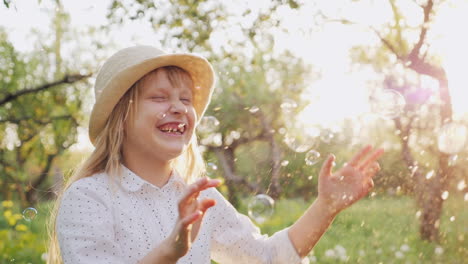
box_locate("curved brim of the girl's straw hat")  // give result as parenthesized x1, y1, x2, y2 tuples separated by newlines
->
(89, 53, 215, 145)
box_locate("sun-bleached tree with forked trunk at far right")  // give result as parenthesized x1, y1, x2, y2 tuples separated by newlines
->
(324, 0, 460, 241)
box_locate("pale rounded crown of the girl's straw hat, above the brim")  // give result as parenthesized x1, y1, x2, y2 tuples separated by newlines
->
(94, 46, 166, 99)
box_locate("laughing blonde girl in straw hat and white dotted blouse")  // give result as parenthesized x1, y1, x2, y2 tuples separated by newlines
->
(49, 46, 383, 264)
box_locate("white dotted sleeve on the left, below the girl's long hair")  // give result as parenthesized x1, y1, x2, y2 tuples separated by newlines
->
(56, 177, 124, 264)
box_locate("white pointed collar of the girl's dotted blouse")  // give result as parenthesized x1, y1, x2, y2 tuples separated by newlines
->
(120, 164, 186, 192)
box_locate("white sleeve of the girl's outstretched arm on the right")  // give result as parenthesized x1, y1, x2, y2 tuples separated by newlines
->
(204, 189, 309, 264)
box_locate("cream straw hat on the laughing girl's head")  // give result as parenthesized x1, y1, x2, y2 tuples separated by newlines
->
(89, 46, 215, 144)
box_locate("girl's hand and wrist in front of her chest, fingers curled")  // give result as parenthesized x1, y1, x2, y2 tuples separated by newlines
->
(167, 178, 221, 261)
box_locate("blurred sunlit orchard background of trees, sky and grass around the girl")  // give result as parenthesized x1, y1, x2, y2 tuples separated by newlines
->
(0, 0, 468, 263)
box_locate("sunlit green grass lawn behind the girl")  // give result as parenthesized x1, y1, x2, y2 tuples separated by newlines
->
(0, 196, 468, 264)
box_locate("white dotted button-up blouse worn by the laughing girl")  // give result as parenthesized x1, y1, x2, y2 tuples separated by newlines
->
(56, 166, 308, 264)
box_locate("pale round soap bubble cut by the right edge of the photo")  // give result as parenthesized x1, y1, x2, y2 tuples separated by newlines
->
(437, 123, 467, 154)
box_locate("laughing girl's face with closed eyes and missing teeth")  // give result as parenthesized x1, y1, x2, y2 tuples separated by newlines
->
(123, 69, 196, 161)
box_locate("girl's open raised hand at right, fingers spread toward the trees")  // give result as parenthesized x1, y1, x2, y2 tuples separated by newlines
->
(318, 145, 384, 213)
